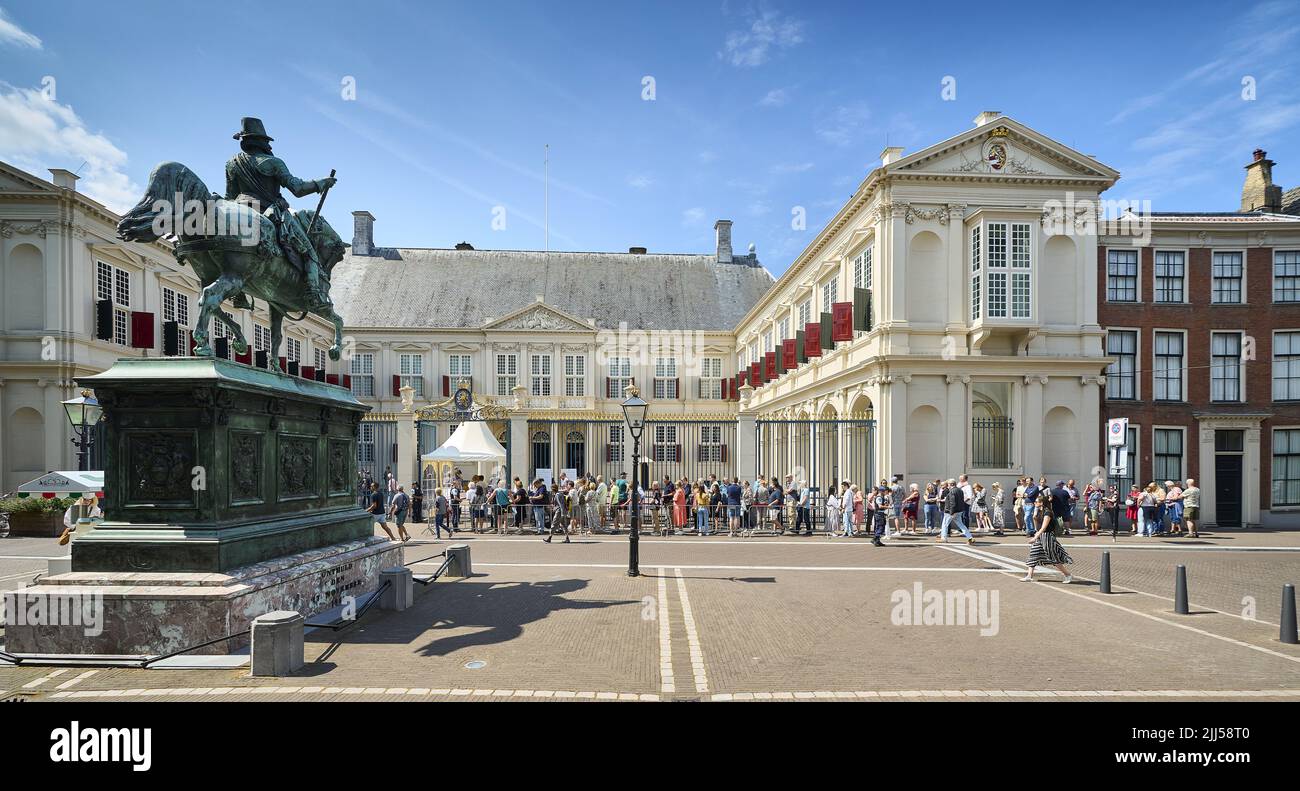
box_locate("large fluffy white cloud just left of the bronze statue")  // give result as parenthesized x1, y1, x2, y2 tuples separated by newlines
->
(0, 82, 144, 213)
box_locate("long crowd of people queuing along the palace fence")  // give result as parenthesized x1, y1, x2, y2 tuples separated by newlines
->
(360, 468, 1200, 582)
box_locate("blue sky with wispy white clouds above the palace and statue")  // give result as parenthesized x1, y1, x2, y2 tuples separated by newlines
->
(0, 0, 1300, 273)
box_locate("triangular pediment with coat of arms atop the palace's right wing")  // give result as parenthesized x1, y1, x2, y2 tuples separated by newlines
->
(885, 116, 1119, 181)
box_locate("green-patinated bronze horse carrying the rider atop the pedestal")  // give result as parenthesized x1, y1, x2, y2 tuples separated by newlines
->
(117, 163, 346, 371)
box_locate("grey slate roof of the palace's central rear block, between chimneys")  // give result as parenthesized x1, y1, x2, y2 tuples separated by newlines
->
(330, 248, 775, 332)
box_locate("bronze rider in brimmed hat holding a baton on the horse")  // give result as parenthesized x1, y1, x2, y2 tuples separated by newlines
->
(225, 118, 335, 308)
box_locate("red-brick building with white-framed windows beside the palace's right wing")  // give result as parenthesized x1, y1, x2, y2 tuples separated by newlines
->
(1097, 151, 1300, 526)
